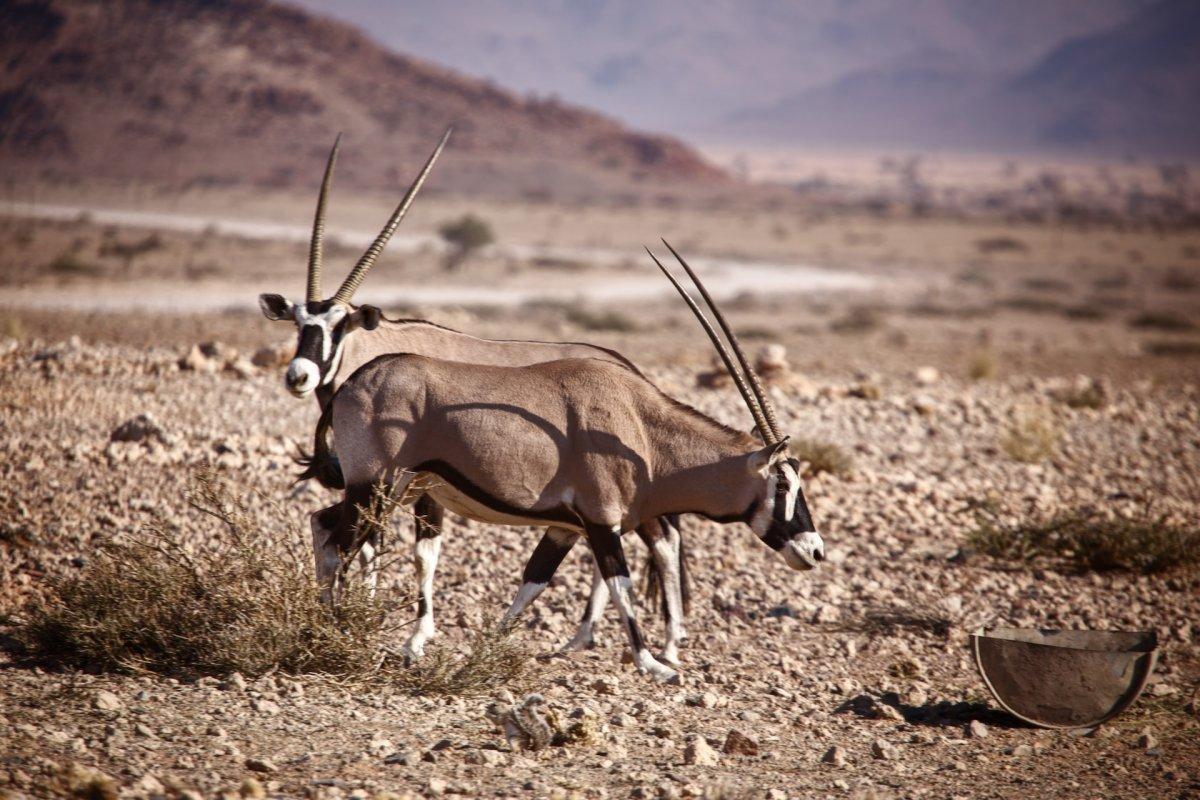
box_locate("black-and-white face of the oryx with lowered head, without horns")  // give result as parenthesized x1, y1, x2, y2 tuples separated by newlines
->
(750, 439, 824, 570)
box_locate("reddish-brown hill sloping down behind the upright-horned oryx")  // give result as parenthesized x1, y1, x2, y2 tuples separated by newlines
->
(0, 0, 726, 197)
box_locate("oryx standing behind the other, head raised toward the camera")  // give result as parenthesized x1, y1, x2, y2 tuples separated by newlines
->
(259, 131, 686, 663)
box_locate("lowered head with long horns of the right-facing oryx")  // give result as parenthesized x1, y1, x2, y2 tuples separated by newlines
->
(646, 240, 824, 570)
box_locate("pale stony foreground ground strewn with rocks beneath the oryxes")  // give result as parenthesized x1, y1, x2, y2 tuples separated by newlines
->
(0, 323, 1200, 798)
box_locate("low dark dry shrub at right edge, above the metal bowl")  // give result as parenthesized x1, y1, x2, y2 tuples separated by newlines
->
(967, 510, 1200, 573)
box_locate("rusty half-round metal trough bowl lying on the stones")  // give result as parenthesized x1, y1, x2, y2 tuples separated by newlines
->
(971, 627, 1158, 728)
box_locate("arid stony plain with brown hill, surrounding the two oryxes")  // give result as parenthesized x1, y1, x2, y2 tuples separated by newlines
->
(0, 0, 1200, 800)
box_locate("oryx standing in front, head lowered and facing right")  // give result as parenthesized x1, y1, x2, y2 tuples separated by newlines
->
(314, 245, 824, 680)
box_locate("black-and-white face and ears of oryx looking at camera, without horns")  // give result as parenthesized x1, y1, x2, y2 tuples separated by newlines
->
(258, 294, 380, 397)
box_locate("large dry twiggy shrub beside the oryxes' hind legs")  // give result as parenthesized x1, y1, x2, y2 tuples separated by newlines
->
(17, 470, 388, 679)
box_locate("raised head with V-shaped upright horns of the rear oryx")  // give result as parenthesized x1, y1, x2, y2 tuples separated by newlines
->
(258, 128, 450, 397)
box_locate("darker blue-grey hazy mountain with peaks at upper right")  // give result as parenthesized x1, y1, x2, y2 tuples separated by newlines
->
(724, 0, 1200, 156)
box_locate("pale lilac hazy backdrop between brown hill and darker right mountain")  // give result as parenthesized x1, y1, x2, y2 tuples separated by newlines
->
(298, 0, 1151, 138)
